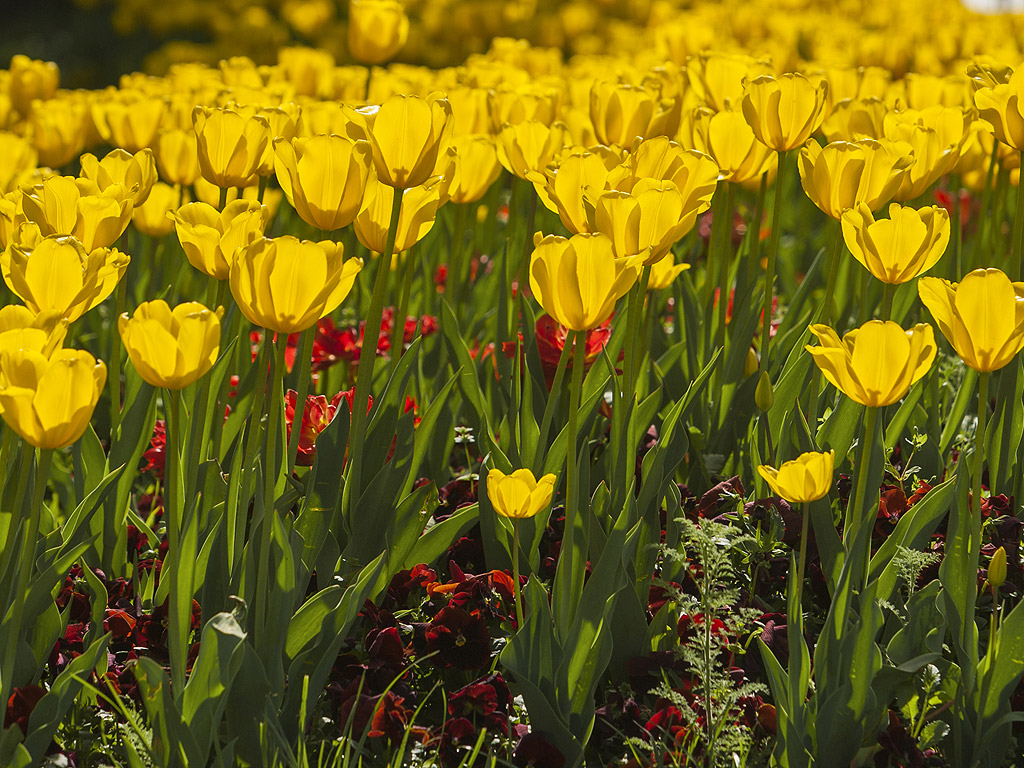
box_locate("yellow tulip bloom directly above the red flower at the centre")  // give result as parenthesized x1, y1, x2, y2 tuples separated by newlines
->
(529, 233, 642, 331)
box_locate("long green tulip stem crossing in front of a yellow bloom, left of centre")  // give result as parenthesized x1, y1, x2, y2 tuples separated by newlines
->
(343, 187, 402, 512)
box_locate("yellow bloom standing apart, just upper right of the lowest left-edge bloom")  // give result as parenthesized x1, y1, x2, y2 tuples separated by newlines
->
(118, 299, 224, 389)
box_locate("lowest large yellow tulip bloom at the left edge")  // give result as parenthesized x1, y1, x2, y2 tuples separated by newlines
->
(0, 349, 106, 449)
